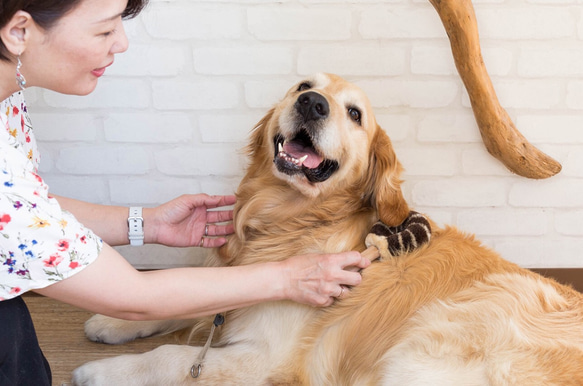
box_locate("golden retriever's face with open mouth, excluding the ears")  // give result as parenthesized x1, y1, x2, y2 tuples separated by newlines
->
(269, 74, 376, 196)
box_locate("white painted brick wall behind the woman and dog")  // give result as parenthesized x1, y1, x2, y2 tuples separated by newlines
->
(27, 0, 583, 267)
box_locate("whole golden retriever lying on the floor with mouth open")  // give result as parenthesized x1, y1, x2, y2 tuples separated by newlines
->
(74, 74, 583, 385)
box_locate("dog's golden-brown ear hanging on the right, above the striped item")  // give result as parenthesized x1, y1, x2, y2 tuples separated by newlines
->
(365, 125, 409, 226)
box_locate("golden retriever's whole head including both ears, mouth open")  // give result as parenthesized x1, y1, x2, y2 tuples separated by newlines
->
(249, 74, 409, 225)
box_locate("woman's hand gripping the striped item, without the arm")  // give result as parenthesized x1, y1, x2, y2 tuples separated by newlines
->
(282, 251, 370, 307)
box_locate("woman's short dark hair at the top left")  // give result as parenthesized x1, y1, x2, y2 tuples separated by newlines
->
(0, 0, 148, 61)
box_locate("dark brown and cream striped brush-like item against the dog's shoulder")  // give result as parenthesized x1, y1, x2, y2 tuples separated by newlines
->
(365, 211, 431, 259)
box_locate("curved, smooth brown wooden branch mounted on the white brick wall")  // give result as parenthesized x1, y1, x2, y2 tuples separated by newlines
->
(429, 0, 561, 179)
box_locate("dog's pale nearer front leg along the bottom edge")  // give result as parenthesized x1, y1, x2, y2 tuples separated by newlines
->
(72, 343, 270, 386)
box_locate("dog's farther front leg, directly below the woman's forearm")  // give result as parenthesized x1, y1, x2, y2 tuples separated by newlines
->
(85, 315, 195, 344)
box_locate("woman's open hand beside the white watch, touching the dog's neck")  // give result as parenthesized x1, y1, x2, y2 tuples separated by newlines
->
(143, 194, 236, 248)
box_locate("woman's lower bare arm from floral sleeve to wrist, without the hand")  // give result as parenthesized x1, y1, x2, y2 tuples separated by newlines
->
(36, 245, 285, 320)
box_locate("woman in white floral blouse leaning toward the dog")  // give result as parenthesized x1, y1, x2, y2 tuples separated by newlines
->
(0, 0, 369, 385)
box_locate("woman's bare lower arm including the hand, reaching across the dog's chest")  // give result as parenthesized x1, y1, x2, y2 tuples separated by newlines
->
(35, 244, 370, 320)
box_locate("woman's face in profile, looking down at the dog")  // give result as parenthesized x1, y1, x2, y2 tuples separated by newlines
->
(21, 0, 128, 95)
